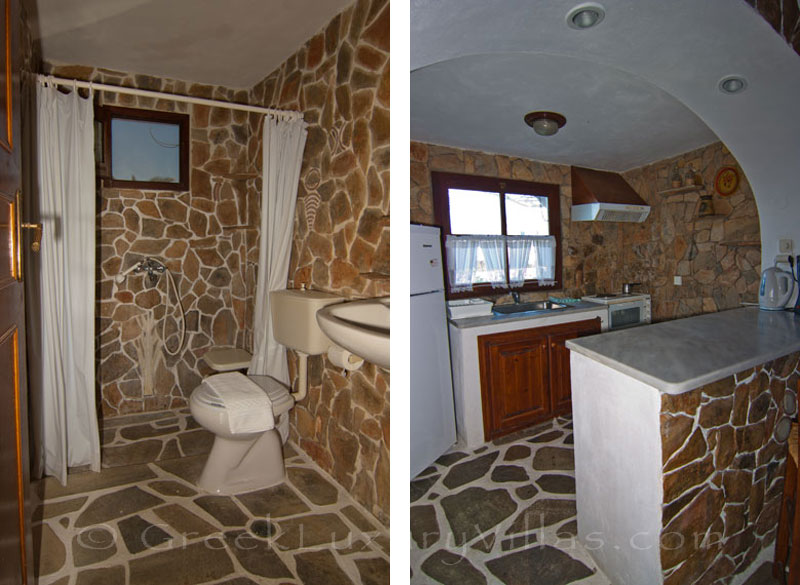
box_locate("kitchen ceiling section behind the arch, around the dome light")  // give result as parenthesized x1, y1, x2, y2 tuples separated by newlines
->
(411, 53, 717, 171)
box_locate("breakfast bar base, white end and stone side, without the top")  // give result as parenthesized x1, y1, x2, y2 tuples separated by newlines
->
(571, 352, 800, 585)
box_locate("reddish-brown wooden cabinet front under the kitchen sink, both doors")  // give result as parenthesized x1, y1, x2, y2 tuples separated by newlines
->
(478, 318, 600, 441)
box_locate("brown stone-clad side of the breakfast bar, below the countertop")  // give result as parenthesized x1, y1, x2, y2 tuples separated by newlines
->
(661, 354, 800, 585)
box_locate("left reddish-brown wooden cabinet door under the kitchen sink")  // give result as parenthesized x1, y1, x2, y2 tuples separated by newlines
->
(478, 329, 550, 441)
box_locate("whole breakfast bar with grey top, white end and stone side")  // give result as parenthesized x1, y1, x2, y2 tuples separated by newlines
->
(567, 308, 800, 585)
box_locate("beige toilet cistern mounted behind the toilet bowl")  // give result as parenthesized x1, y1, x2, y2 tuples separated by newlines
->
(269, 289, 344, 355)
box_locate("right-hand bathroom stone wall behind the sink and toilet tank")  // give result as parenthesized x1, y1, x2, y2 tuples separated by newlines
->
(249, 0, 389, 523)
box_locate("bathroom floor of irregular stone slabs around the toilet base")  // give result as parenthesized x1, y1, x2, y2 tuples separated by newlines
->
(34, 445, 389, 585)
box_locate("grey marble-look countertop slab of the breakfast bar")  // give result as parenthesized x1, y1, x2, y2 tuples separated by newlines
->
(567, 307, 800, 394)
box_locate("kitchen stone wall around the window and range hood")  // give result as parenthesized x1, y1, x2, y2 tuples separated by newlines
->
(411, 142, 761, 321)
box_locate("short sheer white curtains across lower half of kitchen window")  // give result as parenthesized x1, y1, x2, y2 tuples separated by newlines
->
(445, 235, 556, 292)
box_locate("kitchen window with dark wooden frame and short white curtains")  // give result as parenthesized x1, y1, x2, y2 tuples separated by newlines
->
(431, 172, 561, 298)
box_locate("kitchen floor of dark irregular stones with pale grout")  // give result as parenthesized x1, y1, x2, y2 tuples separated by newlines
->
(411, 418, 776, 585)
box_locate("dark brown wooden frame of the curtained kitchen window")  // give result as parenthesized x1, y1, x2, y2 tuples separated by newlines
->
(431, 171, 563, 299)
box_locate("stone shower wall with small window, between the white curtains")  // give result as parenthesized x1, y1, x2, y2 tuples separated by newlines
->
(46, 65, 258, 417)
